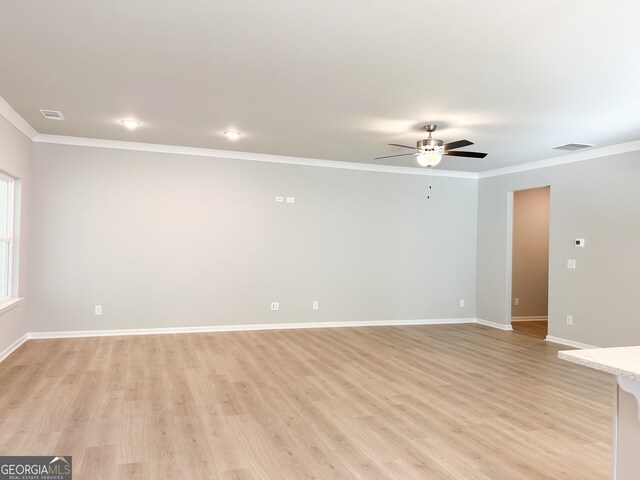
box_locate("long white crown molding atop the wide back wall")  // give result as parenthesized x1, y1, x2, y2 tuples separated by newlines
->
(33, 133, 478, 179)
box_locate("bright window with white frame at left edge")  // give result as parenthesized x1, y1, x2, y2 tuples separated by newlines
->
(0, 173, 14, 301)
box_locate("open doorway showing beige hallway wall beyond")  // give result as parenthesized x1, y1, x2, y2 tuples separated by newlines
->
(511, 187, 551, 338)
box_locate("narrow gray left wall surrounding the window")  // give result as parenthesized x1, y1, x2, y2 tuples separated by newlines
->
(0, 116, 31, 353)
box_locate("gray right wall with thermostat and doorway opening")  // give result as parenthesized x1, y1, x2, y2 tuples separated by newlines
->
(477, 152, 640, 346)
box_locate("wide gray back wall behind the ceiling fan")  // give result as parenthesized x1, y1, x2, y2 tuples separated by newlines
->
(30, 144, 477, 332)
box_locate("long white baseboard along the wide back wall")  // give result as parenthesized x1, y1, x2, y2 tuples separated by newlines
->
(29, 318, 476, 339)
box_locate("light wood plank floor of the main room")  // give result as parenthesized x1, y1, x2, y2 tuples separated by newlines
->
(0, 325, 613, 480)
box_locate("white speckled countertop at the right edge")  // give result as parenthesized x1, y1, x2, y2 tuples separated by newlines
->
(558, 346, 640, 381)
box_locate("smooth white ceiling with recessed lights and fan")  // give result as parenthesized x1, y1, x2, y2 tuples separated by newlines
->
(0, 0, 640, 171)
